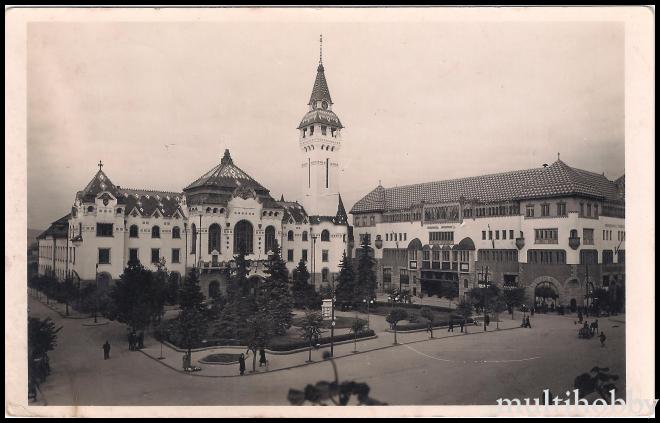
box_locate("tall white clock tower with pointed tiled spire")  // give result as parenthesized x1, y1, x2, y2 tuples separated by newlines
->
(298, 34, 343, 216)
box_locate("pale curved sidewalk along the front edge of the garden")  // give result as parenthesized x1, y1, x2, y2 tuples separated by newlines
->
(140, 316, 520, 377)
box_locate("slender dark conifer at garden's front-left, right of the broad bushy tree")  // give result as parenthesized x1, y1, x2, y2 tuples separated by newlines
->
(174, 268, 208, 357)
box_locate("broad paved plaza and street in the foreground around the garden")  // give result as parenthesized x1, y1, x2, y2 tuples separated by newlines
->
(29, 297, 625, 406)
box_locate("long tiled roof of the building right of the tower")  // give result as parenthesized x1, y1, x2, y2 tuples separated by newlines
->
(351, 160, 623, 217)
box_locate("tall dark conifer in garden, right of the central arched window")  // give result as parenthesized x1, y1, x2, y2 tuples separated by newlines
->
(257, 243, 293, 335)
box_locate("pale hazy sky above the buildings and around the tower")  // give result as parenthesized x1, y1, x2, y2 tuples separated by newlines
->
(27, 20, 625, 229)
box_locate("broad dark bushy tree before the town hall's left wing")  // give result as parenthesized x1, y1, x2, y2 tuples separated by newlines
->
(110, 262, 164, 331)
